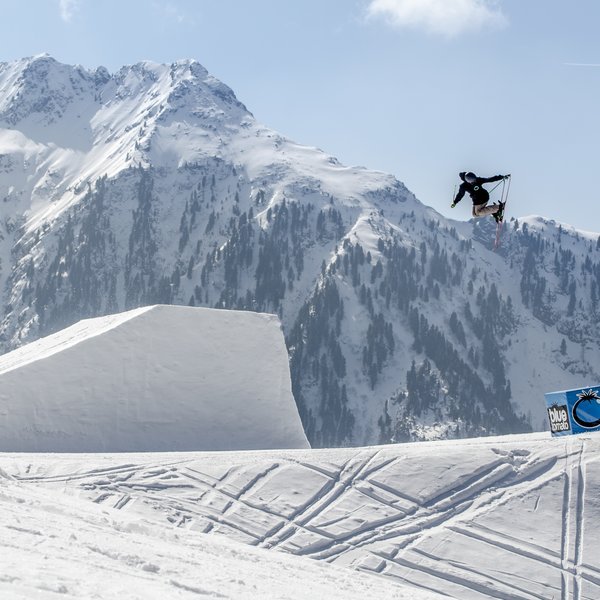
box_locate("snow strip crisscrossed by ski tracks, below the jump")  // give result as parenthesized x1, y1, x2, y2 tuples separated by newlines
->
(0, 435, 600, 600)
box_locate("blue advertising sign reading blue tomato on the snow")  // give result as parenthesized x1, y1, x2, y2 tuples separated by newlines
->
(545, 386, 600, 435)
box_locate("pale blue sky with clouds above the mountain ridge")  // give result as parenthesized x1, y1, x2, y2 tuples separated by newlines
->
(0, 0, 600, 232)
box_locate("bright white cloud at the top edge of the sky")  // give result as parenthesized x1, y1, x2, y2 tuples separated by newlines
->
(367, 0, 508, 37)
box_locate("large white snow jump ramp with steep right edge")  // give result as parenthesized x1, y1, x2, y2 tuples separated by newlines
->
(0, 306, 308, 452)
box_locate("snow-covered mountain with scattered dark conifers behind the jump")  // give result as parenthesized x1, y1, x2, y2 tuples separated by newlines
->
(0, 55, 600, 445)
